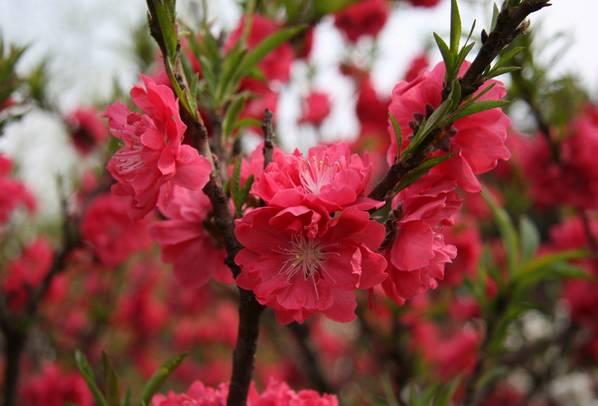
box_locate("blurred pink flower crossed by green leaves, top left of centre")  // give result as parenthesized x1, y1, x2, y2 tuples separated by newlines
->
(225, 14, 293, 82)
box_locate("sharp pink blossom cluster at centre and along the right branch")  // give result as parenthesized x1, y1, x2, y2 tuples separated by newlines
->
(236, 58, 510, 322)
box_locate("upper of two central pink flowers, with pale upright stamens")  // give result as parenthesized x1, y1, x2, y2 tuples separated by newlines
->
(252, 144, 381, 211)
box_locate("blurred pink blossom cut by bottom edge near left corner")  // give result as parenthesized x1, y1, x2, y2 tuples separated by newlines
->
(20, 364, 94, 406)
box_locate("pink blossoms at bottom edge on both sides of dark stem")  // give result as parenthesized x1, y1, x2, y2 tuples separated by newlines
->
(151, 379, 338, 406)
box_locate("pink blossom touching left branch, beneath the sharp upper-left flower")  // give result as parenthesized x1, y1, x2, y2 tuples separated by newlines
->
(149, 186, 232, 286)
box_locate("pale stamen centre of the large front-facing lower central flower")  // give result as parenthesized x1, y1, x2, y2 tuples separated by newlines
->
(280, 234, 326, 281)
